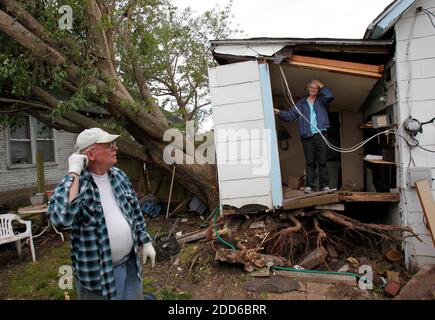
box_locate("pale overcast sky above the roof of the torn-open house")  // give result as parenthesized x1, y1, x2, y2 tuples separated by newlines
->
(173, 0, 393, 131)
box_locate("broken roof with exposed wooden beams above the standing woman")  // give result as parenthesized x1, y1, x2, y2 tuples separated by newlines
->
(210, 38, 394, 112)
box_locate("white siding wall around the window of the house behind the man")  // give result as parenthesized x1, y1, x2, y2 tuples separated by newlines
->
(0, 130, 76, 208)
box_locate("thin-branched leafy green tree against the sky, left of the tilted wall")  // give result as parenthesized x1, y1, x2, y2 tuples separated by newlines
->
(117, 1, 242, 126)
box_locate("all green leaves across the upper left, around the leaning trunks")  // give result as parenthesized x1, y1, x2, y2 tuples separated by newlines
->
(0, 0, 242, 132)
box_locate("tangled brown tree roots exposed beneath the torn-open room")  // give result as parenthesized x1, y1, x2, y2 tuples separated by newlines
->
(215, 209, 421, 272)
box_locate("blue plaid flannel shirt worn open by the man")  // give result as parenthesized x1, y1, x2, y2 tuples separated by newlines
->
(47, 167, 151, 299)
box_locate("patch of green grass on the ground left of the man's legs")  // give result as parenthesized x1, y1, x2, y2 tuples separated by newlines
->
(2, 242, 76, 300)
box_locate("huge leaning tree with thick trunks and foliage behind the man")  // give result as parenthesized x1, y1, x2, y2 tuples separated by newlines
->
(0, 0, 242, 207)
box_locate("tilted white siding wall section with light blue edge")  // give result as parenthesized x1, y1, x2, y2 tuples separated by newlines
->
(209, 61, 283, 209)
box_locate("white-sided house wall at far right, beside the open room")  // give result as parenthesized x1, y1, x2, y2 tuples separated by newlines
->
(394, 0, 435, 268)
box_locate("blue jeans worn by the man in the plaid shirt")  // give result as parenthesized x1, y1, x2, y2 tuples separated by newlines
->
(76, 253, 144, 300)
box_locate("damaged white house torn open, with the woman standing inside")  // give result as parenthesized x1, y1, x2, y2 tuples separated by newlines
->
(209, 0, 435, 268)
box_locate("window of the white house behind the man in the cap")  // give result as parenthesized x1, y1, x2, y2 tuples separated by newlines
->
(9, 117, 55, 165)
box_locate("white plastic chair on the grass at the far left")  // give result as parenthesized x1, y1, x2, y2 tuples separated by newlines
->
(0, 213, 36, 262)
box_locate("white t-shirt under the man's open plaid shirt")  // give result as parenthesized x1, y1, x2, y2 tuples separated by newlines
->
(92, 172, 133, 262)
